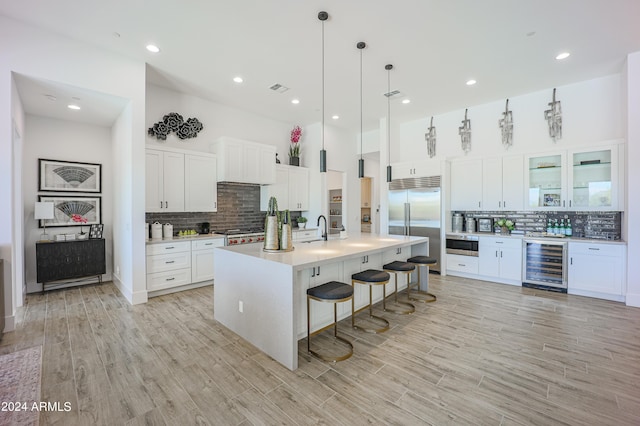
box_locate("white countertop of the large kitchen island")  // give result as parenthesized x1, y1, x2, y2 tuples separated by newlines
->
(216, 234, 429, 267)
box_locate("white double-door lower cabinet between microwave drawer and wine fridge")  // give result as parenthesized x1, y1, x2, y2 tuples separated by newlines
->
(478, 237, 522, 285)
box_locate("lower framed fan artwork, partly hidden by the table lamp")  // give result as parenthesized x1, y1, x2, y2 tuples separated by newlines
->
(39, 195, 102, 228)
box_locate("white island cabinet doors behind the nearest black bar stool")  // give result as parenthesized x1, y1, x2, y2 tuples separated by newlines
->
(298, 262, 344, 335)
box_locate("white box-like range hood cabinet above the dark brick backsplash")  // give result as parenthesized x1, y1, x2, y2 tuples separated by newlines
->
(212, 138, 276, 185)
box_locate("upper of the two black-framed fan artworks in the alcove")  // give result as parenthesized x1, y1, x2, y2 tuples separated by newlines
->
(38, 158, 102, 193)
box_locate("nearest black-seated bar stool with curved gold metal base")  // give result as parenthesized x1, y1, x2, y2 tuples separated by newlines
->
(307, 281, 353, 362)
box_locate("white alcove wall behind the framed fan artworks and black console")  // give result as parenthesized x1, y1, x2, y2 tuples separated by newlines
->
(22, 114, 113, 293)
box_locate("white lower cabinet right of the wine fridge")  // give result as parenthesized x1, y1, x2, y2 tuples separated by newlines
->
(568, 242, 626, 301)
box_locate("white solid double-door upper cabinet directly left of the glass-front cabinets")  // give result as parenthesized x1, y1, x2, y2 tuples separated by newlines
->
(482, 156, 524, 210)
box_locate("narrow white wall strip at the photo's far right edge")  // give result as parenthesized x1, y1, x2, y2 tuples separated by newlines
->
(623, 52, 640, 307)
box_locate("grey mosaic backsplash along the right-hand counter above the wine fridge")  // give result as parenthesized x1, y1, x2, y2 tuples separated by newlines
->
(453, 211, 622, 240)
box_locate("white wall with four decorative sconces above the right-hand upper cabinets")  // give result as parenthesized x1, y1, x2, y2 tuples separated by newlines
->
(398, 74, 625, 163)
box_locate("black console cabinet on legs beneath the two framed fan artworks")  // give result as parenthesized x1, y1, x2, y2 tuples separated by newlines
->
(36, 239, 107, 292)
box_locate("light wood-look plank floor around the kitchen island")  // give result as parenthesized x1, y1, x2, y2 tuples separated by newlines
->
(0, 275, 640, 425)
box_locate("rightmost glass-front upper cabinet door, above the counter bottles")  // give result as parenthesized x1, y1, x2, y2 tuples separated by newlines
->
(569, 146, 618, 211)
